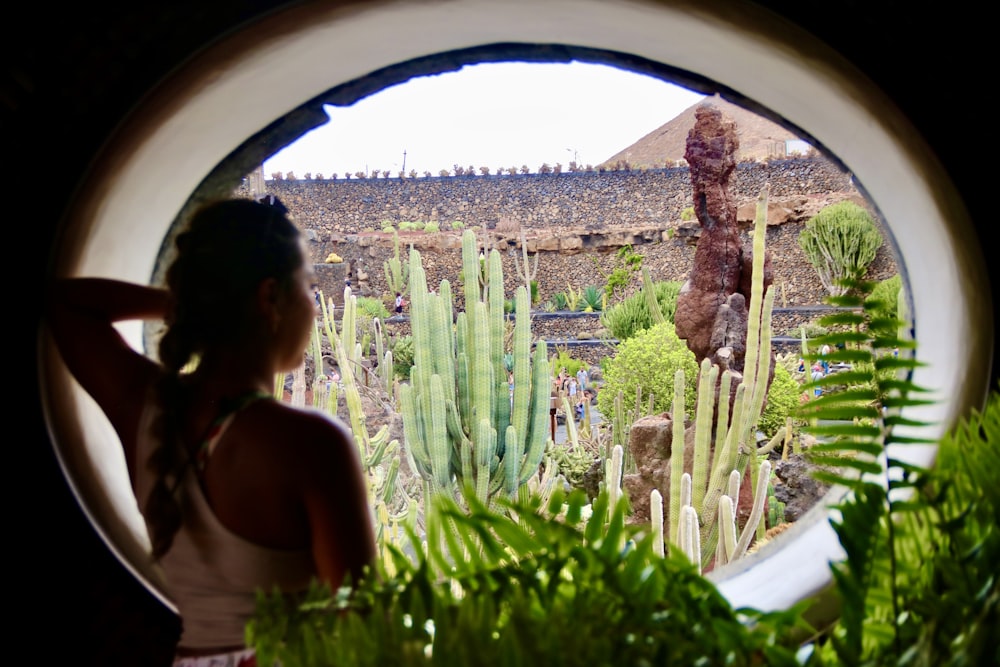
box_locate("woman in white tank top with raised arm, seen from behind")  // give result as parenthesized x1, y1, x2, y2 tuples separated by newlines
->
(49, 200, 375, 665)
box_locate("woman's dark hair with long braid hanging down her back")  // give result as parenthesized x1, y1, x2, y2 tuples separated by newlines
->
(144, 198, 303, 559)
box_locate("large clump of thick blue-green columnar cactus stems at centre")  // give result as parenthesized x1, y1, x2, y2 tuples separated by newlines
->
(399, 230, 550, 502)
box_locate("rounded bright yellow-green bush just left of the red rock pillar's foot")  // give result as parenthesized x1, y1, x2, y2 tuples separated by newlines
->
(597, 322, 698, 417)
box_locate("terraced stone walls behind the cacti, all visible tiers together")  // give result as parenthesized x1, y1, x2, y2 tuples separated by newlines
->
(240, 158, 896, 360)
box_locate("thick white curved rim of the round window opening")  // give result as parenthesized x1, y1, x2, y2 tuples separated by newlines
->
(43, 0, 992, 628)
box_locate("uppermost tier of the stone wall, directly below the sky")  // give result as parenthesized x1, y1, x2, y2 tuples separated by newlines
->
(266, 158, 856, 237)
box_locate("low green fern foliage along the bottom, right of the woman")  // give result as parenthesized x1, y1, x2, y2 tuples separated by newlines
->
(247, 491, 802, 667)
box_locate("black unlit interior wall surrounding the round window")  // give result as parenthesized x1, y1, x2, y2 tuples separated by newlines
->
(11, 0, 998, 665)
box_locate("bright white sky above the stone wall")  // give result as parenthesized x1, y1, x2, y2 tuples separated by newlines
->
(264, 63, 703, 178)
